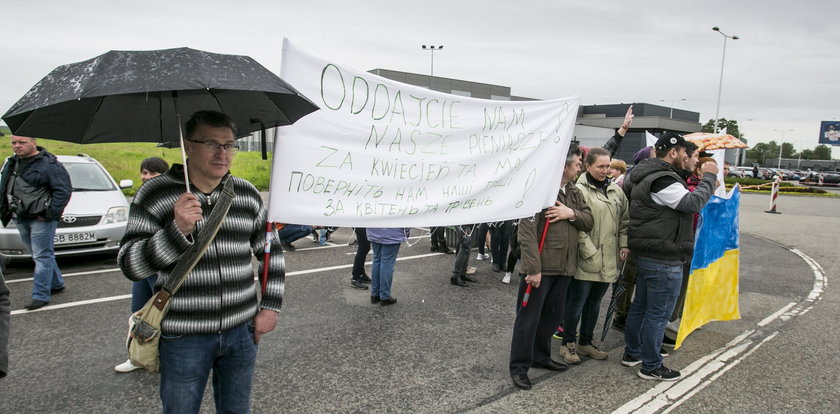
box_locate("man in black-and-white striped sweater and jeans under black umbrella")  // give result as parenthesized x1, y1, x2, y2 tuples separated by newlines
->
(118, 111, 284, 413)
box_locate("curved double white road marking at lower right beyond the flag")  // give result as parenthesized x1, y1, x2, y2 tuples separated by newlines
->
(613, 249, 828, 414)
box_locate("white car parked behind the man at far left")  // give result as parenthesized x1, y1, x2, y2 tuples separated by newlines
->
(0, 154, 134, 261)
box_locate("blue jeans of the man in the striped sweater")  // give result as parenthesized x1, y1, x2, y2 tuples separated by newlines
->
(159, 322, 257, 414)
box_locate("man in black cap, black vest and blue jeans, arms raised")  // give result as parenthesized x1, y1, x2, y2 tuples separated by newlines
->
(621, 133, 718, 381)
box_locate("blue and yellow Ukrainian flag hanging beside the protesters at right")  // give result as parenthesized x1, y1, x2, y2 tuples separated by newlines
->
(674, 184, 741, 349)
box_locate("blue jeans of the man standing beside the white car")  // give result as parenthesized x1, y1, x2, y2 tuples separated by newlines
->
(16, 218, 64, 302)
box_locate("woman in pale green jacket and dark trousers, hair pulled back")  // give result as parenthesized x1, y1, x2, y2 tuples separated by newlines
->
(560, 148, 630, 364)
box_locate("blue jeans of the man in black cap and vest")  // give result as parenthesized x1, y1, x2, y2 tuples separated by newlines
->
(624, 256, 683, 371)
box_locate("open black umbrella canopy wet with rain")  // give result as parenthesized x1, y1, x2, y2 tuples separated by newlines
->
(3, 48, 318, 146)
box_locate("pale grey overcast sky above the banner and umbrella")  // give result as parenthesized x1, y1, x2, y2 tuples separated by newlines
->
(0, 0, 840, 152)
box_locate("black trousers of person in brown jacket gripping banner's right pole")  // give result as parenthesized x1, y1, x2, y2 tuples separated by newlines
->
(510, 274, 572, 375)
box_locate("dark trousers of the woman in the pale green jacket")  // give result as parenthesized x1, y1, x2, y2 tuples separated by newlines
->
(563, 279, 610, 345)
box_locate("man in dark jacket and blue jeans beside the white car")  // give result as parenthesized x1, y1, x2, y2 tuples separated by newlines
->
(0, 135, 73, 310)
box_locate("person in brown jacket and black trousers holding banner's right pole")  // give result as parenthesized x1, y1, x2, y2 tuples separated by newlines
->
(510, 146, 593, 390)
